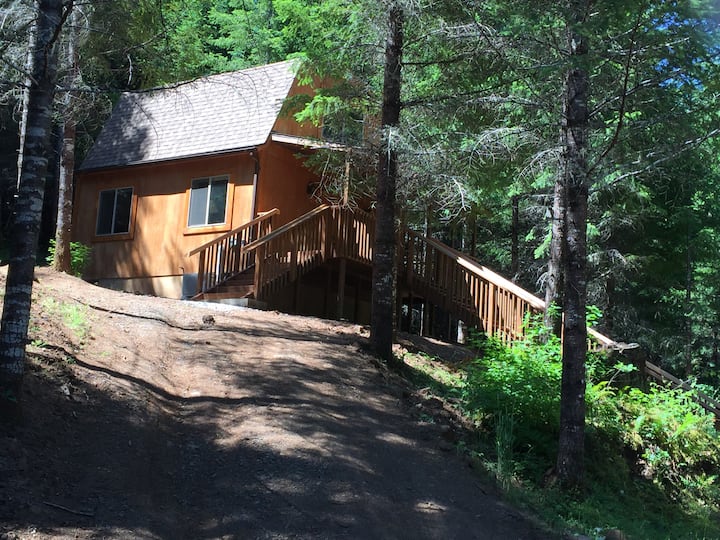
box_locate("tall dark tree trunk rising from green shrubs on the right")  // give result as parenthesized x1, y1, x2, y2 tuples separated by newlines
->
(557, 0, 590, 488)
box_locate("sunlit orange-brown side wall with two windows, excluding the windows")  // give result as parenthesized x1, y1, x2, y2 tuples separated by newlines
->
(73, 154, 255, 282)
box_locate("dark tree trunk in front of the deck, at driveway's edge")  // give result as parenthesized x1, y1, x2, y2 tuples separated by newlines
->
(370, 3, 403, 362)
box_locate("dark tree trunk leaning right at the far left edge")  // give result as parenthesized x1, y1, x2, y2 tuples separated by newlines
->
(0, 0, 70, 409)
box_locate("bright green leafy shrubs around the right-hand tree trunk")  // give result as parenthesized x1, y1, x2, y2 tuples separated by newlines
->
(462, 314, 720, 506)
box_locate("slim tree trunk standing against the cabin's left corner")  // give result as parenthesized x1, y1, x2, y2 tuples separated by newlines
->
(53, 5, 78, 274)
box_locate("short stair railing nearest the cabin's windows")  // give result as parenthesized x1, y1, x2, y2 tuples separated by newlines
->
(188, 208, 280, 294)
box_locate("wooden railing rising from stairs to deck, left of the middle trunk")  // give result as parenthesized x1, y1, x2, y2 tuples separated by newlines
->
(243, 205, 374, 300)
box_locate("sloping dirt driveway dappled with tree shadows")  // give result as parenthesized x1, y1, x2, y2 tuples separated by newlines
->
(0, 268, 557, 540)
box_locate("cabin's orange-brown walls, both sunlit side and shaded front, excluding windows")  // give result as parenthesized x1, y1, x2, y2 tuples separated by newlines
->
(73, 143, 318, 292)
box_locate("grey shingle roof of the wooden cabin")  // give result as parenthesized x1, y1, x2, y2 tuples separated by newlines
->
(80, 61, 296, 170)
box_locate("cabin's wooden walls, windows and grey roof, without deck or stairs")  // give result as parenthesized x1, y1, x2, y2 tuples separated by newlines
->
(73, 61, 346, 304)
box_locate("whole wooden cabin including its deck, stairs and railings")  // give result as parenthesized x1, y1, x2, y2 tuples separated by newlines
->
(73, 61, 572, 339)
